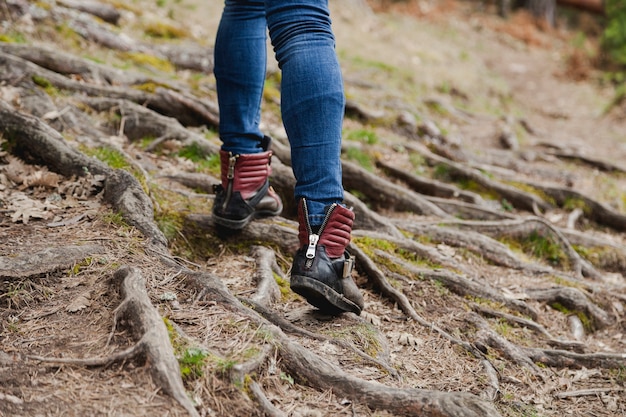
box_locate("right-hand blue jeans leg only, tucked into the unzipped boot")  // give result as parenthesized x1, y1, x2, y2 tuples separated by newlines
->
(266, 0, 345, 225)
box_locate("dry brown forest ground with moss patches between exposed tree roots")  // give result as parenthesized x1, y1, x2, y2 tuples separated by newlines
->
(0, 0, 626, 417)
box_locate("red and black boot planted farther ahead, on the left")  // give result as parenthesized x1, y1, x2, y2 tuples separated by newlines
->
(213, 137, 283, 231)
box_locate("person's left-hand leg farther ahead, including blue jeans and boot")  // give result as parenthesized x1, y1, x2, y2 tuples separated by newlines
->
(213, 0, 282, 230)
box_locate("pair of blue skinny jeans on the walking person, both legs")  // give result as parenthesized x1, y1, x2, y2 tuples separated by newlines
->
(214, 0, 345, 225)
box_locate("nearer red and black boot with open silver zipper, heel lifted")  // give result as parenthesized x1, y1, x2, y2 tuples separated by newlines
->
(291, 199, 364, 315)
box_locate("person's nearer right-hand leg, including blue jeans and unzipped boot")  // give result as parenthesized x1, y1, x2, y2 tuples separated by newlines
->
(265, 0, 363, 314)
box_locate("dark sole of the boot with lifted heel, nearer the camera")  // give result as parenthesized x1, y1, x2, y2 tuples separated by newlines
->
(290, 275, 361, 316)
